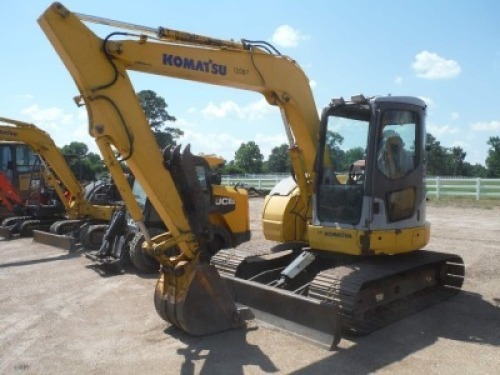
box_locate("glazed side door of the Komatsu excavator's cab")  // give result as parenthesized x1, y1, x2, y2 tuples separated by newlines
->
(370, 101, 425, 229)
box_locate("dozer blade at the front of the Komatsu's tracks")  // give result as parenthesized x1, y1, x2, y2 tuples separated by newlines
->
(222, 275, 342, 350)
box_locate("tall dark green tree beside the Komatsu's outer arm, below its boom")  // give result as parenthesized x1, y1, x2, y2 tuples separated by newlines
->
(137, 90, 184, 149)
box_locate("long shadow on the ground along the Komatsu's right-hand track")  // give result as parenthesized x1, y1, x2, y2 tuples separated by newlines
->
(293, 291, 500, 375)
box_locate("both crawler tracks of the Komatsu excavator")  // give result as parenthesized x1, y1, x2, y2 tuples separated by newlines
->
(211, 242, 465, 344)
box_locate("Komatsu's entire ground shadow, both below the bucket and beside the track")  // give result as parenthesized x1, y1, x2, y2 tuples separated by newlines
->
(165, 291, 500, 375)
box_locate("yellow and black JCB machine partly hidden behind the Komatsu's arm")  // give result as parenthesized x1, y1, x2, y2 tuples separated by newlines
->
(85, 154, 250, 273)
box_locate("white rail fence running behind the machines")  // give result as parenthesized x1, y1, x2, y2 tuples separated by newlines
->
(222, 174, 500, 200)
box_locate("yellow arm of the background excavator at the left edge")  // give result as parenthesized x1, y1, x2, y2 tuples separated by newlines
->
(0, 117, 114, 220)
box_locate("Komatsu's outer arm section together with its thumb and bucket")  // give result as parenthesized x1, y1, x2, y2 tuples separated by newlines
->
(39, 3, 262, 335)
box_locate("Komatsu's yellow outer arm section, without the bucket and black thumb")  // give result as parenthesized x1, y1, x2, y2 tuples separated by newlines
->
(39, 3, 203, 259)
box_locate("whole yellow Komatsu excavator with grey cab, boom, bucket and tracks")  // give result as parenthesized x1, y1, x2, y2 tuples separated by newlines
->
(39, 3, 464, 346)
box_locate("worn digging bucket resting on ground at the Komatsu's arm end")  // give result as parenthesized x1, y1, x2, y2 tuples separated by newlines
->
(154, 264, 253, 336)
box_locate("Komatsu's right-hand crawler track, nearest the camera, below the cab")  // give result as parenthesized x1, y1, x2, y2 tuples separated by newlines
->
(309, 250, 464, 334)
